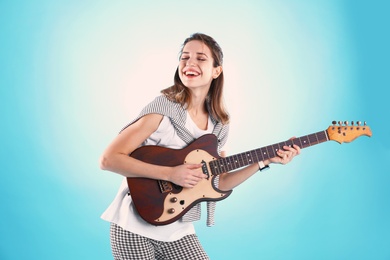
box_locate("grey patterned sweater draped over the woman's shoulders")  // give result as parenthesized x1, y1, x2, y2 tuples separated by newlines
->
(121, 95, 229, 226)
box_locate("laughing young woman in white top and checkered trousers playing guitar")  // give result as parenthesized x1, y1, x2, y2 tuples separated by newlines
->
(100, 33, 300, 259)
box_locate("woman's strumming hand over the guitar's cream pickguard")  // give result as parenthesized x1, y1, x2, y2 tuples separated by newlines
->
(169, 164, 206, 188)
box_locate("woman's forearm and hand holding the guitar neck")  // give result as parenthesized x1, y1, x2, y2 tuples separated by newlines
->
(219, 142, 301, 191)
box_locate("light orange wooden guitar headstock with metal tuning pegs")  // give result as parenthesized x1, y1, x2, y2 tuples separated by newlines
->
(326, 121, 372, 144)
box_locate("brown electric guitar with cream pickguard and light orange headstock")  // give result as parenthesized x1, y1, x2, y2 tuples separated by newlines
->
(127, 121, 372, 225)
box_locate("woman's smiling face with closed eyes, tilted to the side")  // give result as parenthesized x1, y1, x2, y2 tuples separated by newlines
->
(178, 40, 222, 93)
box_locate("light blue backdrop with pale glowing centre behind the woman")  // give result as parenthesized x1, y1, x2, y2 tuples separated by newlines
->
(0, 0, 390, 259)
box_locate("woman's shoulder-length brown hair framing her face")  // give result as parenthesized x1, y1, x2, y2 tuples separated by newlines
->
(161, 33, 229, 124)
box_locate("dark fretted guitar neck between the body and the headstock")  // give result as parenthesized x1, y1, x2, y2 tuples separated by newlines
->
(210, 130, 329, 175)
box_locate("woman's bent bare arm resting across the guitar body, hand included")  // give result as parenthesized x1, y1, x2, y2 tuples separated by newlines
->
(100, 114, 204, 188)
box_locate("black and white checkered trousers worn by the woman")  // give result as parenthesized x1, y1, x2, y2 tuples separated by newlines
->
(110, 223, 209, 260)
